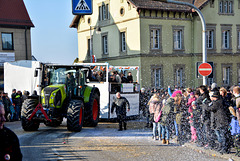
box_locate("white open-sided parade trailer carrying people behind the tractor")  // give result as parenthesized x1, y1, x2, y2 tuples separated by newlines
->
(75, 63, 140, 119)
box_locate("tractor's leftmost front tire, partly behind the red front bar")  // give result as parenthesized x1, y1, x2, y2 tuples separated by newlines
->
(21, 99, 40, 131)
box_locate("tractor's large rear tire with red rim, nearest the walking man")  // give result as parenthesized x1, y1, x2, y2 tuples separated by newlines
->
(84, 93, 100, 127)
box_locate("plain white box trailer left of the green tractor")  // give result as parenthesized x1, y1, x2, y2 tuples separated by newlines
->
(4, 60, 42, 96)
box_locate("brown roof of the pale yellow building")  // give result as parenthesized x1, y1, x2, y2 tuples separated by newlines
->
(70, 0, 209, 28)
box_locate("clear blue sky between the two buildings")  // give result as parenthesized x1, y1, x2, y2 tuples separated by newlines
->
(23, 0, 78, 64)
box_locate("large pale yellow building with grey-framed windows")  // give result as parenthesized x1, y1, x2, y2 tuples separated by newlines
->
(70, 0, 240, 88)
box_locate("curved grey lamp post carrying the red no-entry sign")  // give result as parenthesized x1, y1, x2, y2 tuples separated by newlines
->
(155, 0, 207, 85)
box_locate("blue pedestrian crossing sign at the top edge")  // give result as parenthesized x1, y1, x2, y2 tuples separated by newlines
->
(72, 0, 92, 15)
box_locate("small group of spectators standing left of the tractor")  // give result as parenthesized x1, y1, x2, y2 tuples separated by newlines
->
(0, 89, 29, 121)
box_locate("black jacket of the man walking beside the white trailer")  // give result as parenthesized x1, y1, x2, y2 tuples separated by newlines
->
(111, 97, 130, 115)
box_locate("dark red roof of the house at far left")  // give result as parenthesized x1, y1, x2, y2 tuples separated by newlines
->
(0, 0, 34, 27)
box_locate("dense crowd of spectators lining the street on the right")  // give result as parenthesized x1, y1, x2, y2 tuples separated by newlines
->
(140, 83, 240, 154)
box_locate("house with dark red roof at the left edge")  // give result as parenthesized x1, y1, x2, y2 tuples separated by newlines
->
(0, 0, 34, 88)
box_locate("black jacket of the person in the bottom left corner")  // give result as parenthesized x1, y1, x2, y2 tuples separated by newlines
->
(0, 127, 22, 161)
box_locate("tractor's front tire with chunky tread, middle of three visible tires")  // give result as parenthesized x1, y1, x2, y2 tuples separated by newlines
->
(67, 100, 84, 132)
